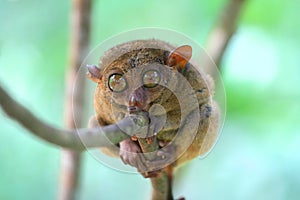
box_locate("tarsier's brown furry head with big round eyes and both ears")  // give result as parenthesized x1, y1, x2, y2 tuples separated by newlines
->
(87, 40, 192, 120)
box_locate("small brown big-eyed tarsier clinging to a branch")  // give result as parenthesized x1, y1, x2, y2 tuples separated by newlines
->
(88, 39, 219, 199)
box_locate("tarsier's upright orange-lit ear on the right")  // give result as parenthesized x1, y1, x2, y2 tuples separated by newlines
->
(166, 45, 192, 70)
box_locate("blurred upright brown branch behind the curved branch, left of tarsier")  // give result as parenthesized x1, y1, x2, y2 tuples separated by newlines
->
(58, 0, 91, 200)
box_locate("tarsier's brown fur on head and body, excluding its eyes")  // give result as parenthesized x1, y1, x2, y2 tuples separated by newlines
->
(90, 40, 219, 198)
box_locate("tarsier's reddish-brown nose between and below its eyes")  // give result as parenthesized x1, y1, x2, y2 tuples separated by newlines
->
(128, 88, 147, 113)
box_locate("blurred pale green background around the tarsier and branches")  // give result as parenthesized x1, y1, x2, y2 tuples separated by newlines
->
(0, 0, 300, 200)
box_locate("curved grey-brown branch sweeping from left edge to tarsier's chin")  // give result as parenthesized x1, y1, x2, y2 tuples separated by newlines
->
(0, 82, 149, 151)
